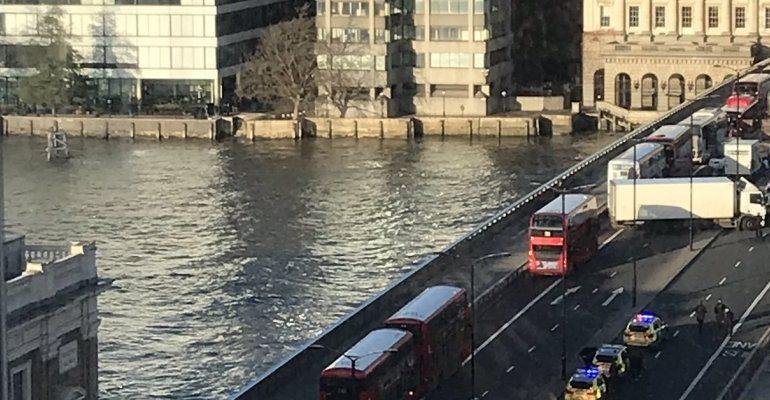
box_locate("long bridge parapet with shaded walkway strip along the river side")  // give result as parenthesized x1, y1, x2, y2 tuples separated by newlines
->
(231, 60, 770, 400)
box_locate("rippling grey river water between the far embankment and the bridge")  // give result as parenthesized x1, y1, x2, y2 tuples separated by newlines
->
(2, 135, 615, 400)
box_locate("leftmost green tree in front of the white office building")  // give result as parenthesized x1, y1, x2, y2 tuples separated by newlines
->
(19, 7, 87, 114)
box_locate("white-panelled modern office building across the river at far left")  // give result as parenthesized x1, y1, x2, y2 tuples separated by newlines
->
(0, 0, 293, 111)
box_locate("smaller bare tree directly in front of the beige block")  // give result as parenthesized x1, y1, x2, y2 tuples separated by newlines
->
(316, 38, 374, 118)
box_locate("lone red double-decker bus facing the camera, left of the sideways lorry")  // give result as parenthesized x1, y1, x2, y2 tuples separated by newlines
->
(529, 194, 599, 275)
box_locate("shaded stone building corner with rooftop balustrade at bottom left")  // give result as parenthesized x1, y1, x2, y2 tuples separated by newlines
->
(5, 235, 108, 400)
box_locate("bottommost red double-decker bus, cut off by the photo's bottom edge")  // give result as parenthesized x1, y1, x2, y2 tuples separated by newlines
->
(321, 328, 419, 400)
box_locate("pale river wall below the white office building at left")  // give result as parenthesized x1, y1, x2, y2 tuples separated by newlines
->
(2, 115, 232, 140)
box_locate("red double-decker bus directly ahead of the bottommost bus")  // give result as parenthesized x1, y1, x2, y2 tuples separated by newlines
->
(385, 286, 471, 396)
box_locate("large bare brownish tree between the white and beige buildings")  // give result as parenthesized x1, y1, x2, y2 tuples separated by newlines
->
(237, 6, 316, 119)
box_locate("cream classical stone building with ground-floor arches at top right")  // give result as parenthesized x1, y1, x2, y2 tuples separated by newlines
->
(582, 0, 756, 111)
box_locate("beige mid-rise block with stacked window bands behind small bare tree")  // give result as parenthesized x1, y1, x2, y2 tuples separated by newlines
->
(316, 0, 513, 117)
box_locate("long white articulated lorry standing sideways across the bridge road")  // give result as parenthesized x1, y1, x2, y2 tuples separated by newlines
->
(607, 176, 767, 230)
